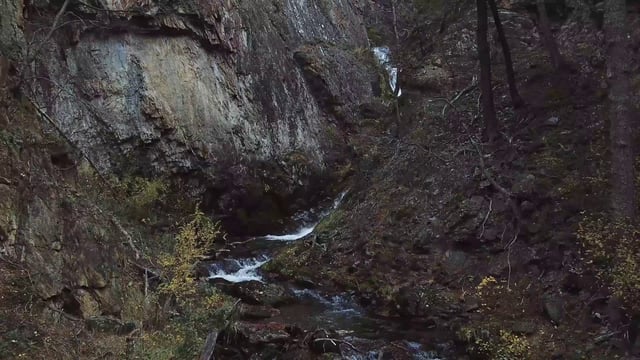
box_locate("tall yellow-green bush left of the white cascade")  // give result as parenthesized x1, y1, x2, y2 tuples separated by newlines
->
(132, 209, 234, 360)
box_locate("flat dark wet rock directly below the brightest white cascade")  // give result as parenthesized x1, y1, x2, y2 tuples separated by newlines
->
(217, 281, 295, 306)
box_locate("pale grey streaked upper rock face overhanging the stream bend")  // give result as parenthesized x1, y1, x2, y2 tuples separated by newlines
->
(26, 0, 376, 231)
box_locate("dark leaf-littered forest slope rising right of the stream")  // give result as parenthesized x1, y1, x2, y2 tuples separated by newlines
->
(270, 5, 637, 359)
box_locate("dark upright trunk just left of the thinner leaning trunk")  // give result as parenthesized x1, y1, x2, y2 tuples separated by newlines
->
(476, 0, 498, 141)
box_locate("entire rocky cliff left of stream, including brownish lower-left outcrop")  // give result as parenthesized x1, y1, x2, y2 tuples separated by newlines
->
(0, 0, 377, 357)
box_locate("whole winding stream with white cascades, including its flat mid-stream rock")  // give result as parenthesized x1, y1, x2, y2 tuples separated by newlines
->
(209, 192, 440, 360)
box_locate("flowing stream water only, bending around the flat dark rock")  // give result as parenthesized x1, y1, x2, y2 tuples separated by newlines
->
(209, 192, 442, 360)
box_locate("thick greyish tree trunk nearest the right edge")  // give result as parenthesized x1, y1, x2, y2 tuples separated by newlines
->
(604, 0, 636, 220)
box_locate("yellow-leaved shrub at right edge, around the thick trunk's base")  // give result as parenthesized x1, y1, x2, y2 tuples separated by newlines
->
(577, 214, 640, 312)
